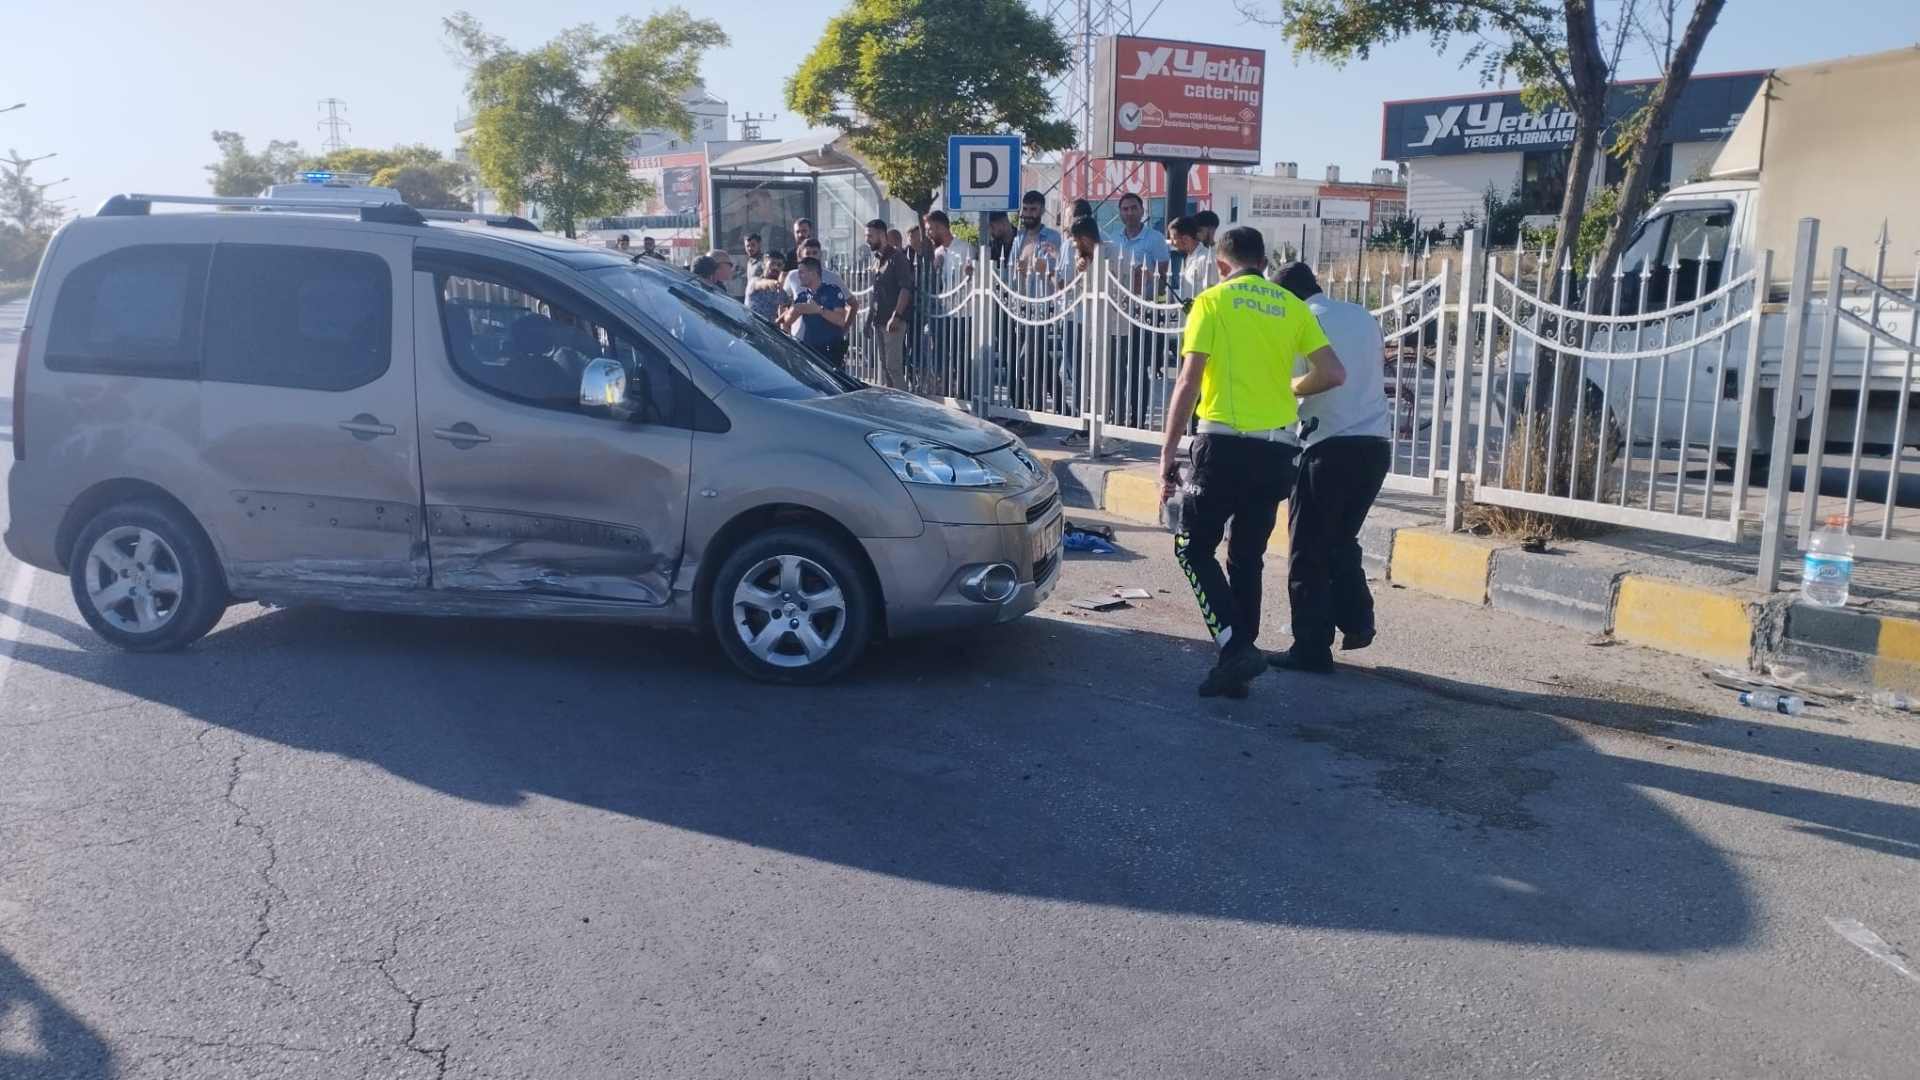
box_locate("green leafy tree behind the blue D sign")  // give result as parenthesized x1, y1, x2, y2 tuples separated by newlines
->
(787, 0, 1073, 213)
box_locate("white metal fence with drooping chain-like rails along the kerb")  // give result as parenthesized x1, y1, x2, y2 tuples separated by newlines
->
(798, 221, 1920, 586)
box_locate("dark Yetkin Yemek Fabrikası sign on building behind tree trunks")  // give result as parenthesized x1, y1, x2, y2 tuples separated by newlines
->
(1380, 71, 1766, 161)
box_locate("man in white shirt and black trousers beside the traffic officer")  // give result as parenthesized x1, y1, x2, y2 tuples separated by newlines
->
(1271, 263, 1392, 673)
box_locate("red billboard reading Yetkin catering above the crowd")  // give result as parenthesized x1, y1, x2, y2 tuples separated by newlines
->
(1087, 37, 1267, 165)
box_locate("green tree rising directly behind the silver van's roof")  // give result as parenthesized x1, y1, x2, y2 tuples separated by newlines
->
(444, 8, 728, 236)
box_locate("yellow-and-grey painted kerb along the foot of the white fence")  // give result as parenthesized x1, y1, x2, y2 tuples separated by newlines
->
(1035, 440, 1920, 694)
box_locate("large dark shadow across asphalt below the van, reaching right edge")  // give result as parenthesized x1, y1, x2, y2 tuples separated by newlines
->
(17, 591, 1920, 953)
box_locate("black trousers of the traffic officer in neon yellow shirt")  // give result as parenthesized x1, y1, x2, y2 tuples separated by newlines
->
(1173, 434, 1300, 650)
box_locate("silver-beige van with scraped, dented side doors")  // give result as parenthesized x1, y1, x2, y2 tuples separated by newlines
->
(6, 196, 1062, 682)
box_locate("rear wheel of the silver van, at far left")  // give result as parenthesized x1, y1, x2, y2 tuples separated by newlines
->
(67, 502, 227, 651)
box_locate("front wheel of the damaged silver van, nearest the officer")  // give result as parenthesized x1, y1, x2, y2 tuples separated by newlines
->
(708, 528, 874, 684)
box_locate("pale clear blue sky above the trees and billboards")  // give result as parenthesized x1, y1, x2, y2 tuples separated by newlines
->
(11, 0, 1920, 211)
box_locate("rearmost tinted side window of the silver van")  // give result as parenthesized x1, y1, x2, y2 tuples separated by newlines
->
(46, 244, 213, 379)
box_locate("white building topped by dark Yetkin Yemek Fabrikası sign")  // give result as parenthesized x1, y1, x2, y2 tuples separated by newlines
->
(1380, 71, 1766, 229)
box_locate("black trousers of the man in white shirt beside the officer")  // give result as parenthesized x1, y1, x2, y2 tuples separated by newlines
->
(1286, 436, 1392, 659)
